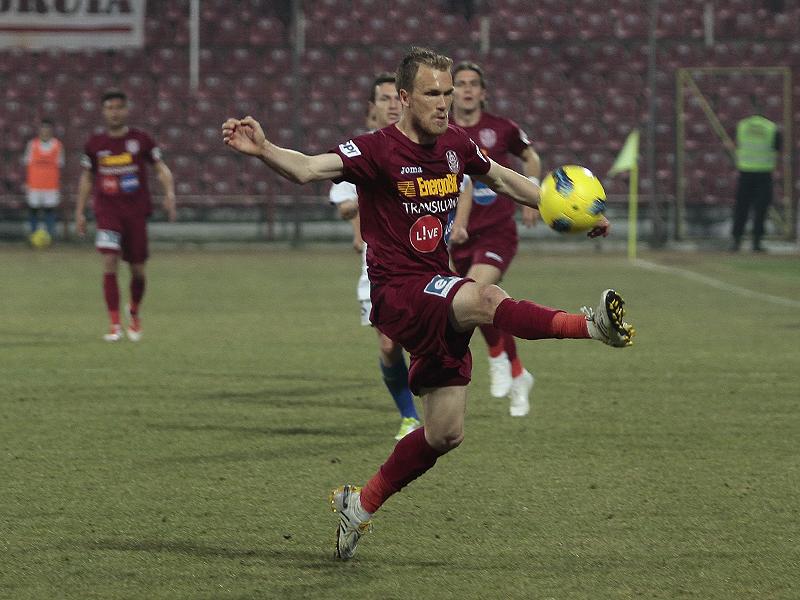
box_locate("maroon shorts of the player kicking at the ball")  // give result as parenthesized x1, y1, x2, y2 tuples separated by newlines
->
(370, 273, 472, 396)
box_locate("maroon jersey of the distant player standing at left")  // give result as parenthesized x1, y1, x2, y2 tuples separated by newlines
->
(81, 128, 161, 215)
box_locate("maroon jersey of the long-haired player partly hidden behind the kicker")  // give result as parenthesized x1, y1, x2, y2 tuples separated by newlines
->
(456, 112, 530, 235)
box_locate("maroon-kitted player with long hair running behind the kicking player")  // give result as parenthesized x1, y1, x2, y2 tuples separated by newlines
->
(450, 62, 541, 417)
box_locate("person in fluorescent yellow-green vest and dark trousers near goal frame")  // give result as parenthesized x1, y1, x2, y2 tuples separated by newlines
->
(729, 102, 781, 252)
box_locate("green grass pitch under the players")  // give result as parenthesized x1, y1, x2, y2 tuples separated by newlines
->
(0, 244, 800, 600)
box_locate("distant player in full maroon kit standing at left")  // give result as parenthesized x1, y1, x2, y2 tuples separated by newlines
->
(75, 90, 175, 342)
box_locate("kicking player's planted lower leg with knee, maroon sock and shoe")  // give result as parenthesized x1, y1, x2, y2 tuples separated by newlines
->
(330, 386, 467, 560)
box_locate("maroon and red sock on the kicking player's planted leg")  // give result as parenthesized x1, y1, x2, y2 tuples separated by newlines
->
(361, 427, 442, 513)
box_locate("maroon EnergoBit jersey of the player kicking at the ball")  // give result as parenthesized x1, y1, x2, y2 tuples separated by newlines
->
(332, 125, 489, 285)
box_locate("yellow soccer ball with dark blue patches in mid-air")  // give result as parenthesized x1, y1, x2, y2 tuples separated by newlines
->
(539, 165, 606, 233)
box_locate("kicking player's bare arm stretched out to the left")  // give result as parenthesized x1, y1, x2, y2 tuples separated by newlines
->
(222, 117, 344, 183)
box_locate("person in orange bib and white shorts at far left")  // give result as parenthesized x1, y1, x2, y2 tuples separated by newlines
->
(23, 119, 64, 238)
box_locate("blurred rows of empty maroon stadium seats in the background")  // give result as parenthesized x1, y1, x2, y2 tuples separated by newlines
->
(0, 0, 800, 223)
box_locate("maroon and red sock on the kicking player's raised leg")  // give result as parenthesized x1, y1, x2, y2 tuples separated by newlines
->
(494, 298, 589, 340)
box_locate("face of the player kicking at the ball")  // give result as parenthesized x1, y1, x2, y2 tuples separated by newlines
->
(403, 65, 453, 136)
